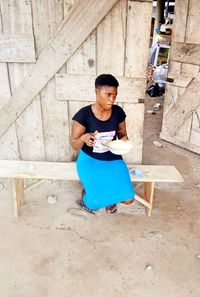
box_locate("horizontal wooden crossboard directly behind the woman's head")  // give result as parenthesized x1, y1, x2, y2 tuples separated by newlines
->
(56, 74, 146, 103)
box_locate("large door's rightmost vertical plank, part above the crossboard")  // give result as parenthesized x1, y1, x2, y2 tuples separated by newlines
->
(125, 0, 152, 77)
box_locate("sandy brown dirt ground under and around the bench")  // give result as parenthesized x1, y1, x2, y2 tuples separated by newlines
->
(0, 93, 200, 297)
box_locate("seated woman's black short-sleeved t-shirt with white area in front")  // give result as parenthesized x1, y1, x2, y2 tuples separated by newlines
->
(72, 105, 126, 161)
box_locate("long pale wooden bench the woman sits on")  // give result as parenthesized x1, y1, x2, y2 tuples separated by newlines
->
(0, 160, 183, 217)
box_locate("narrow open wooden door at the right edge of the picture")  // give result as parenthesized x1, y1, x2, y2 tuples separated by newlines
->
(160, 0, 200, 154)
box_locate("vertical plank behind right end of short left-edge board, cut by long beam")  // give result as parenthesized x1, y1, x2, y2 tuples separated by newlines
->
(1, 0, 45, 160)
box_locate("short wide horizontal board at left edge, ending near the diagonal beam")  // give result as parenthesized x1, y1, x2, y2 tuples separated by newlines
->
(0, 34, 36, 63)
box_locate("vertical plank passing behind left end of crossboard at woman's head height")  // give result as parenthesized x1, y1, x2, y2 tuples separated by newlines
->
(32, 0, 72, 161)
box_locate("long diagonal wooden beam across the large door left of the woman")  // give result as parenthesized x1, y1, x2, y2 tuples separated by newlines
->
(0, 0, 119, 136)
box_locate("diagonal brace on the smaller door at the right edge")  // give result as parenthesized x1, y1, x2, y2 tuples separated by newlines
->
(161, 74, 200, 139)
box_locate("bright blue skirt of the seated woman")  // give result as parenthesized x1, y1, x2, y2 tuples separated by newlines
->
(76, 150, 135, 210)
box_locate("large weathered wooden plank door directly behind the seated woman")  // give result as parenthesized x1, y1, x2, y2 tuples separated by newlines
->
(0, 0, 152, 163)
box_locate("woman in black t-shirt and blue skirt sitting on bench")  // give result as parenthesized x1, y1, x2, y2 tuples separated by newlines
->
(71, 74, 135, 213)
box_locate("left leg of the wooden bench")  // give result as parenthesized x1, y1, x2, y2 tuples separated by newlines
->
(13, 178, 24, 217)
